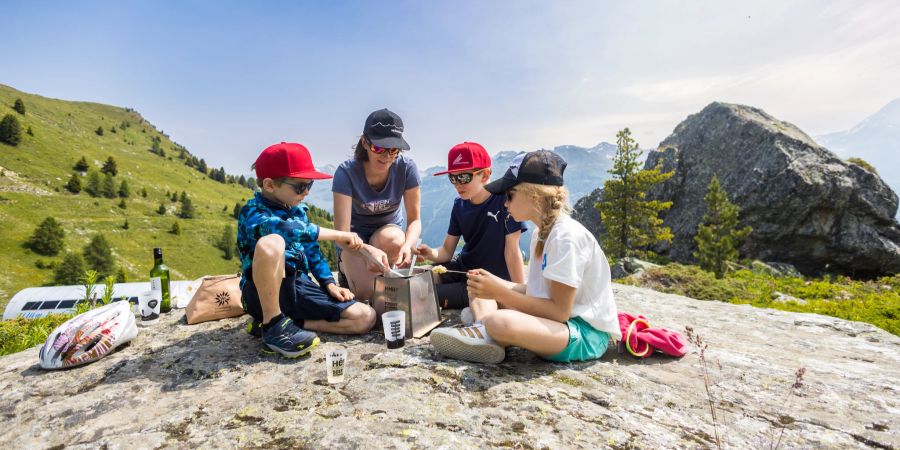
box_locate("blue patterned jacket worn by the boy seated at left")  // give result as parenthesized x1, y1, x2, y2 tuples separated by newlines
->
(237, 192, 334, 288)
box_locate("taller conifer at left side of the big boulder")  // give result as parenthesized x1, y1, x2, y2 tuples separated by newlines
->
(594, 128, 674, 258)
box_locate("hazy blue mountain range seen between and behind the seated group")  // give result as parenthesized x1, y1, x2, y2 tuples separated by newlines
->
(307, 142, 616, 255)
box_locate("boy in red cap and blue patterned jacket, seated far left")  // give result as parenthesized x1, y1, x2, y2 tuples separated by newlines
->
(237, 142, 375, 358)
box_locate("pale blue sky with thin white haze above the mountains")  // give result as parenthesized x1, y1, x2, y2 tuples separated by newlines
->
(0, 0, 900, 173)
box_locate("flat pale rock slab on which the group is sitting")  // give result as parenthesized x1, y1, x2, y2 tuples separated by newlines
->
(0, 285, 900, 449)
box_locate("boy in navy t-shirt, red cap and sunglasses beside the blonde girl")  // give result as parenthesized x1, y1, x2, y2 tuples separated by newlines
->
(416, 142, 527, 312)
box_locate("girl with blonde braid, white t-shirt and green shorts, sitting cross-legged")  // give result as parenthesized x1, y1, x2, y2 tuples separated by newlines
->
(431, 150, 621, 363)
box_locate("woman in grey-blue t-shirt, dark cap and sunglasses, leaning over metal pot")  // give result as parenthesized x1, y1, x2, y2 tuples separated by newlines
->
(331, 109, 422, 299)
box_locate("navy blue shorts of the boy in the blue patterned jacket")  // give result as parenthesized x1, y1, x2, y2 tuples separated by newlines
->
(241, 268, 356, 322)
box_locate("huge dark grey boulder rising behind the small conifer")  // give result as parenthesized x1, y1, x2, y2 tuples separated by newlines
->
(645, 102, 900, 276)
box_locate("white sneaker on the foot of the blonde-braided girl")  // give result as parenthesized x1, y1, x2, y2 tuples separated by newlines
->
(431, 325, 506, 364)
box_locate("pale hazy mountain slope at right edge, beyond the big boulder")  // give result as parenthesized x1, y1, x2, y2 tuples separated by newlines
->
(815, 98, 900, 216)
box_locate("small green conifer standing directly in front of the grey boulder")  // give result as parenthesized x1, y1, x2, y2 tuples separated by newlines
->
(694, 176, 753, 279)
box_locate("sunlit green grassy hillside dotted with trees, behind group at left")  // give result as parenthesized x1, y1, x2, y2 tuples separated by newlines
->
(0, 85, 334, 310)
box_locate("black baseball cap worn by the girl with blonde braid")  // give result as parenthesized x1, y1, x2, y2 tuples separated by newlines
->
(484, 150, 566, 194)
